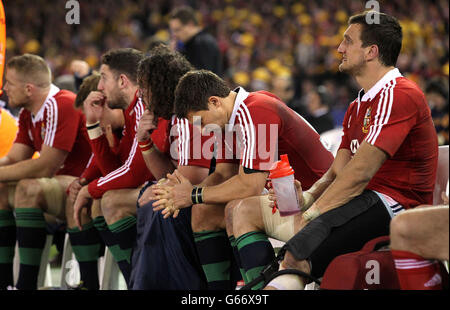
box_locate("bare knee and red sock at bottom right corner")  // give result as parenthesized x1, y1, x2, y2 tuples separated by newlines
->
(390, 205, 449, 290)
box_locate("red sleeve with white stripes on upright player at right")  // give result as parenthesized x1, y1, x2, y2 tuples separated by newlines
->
(365, 88, 418, 157)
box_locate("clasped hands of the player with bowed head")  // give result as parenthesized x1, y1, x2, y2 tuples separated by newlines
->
(153, 170, 194, 210)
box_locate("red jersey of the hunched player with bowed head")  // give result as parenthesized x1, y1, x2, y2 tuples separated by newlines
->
(226, 88, 333, 190)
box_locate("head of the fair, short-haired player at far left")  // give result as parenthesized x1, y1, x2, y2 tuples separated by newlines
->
(3, 54, 52, 107)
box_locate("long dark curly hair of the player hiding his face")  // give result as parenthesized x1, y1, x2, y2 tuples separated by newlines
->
(137, 45, 194, 119)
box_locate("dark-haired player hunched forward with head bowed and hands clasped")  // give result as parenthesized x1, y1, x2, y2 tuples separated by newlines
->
(155, 70, 333, 288)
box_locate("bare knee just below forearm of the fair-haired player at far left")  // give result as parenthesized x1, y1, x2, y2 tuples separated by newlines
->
(14, 179, 44, 208)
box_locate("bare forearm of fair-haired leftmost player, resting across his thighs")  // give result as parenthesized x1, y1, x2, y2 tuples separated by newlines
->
(0, 158, 58, 182)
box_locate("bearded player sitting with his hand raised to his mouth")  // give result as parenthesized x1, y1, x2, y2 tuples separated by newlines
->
(73, 48, 171, 284)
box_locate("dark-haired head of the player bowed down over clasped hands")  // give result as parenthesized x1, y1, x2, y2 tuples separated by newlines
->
(175, 70, 231, 128)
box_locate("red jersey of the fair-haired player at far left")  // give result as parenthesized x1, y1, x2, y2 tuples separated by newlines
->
(15, 85, 91, 177)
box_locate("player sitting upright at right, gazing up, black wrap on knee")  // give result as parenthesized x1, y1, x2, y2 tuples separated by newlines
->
(266, 12, 438, 289)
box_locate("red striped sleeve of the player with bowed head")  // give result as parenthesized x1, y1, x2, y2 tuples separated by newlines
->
(236, 106, 281, 171)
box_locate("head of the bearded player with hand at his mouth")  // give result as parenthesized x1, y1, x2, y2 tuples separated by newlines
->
(97, 48, 144, 109)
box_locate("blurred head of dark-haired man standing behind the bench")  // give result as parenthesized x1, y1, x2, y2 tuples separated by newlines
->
(169, 6, 199, 42)
